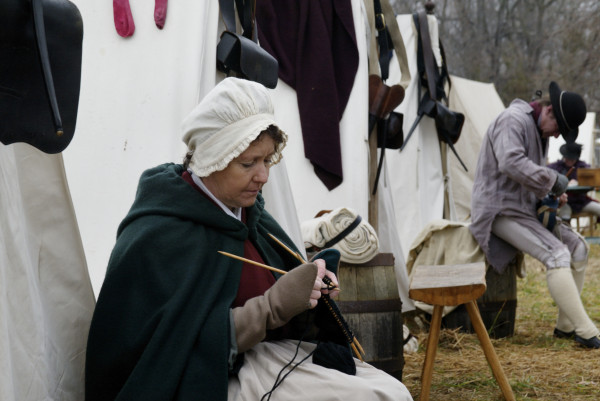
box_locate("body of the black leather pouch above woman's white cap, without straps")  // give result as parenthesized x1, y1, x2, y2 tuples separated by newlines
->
(217, 31, 279, 89)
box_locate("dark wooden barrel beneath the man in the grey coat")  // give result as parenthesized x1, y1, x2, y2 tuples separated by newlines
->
(442, 261, 517, 338)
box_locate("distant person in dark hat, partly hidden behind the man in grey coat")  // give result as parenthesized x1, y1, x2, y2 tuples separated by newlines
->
(548, 142, 600, 222)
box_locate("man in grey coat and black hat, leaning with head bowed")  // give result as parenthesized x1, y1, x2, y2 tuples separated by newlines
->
(470, 82, 600, 348)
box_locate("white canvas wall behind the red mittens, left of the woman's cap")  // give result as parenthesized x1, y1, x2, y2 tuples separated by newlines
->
(63, 0, 219, 294)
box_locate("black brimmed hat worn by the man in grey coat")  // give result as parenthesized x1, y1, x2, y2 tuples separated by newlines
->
(549, 81, 587, 143)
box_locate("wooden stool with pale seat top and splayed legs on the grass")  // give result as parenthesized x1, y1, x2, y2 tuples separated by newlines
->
(408, 262, 515, 401)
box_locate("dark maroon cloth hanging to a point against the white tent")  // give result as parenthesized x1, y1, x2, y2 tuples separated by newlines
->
(256, 0, 358, 190)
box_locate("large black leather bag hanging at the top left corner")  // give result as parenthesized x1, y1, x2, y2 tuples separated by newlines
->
(0, 0, 83, 153)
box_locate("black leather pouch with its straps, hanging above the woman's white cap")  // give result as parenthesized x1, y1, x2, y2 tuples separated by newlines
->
(217, 0, 279, 89)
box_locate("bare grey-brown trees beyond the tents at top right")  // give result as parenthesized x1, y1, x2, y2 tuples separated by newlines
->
(390, 0, 600, 111)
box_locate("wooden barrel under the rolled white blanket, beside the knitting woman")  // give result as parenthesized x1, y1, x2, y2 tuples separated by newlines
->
(334, 253, 404, 380)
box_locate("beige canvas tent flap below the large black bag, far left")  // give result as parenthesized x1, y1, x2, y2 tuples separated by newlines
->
(0, 143, 95, 401)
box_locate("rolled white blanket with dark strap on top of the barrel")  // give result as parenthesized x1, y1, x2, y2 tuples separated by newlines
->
(300, 207, 379, 264)
